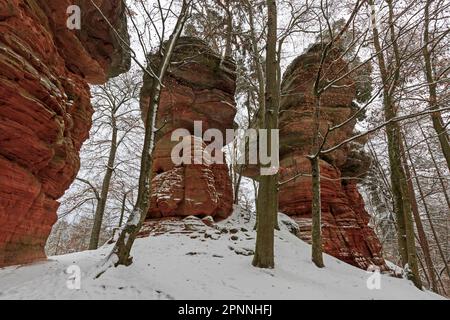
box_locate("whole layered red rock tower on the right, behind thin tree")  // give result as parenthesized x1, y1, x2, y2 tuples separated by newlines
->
(279, 47, 387, 269)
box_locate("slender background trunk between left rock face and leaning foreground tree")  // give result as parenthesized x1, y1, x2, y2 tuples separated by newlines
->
(89, 115, 117, 250)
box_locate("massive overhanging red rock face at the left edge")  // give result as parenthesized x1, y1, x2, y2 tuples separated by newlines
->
(0, 0, 130, 266)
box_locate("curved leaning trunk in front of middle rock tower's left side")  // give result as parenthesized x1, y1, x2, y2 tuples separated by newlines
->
(98, 0, 191, 270)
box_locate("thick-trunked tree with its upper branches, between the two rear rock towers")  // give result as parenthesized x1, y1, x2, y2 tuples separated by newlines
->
(248, 1, 311, 268)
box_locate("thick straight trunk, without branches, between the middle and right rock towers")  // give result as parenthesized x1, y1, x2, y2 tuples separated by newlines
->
(253, 0, 280, 268)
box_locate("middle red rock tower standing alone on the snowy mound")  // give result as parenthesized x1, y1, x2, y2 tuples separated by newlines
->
(141, 37, 236, 220)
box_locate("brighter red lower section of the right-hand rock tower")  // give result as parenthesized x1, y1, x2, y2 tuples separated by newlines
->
(279, 155, 387, 270)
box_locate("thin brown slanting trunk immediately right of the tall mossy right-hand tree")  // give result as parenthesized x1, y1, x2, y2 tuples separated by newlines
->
(401, 137, 438, 292)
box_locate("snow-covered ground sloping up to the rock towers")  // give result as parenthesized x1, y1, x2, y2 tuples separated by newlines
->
(0, 210, 443, 299)
